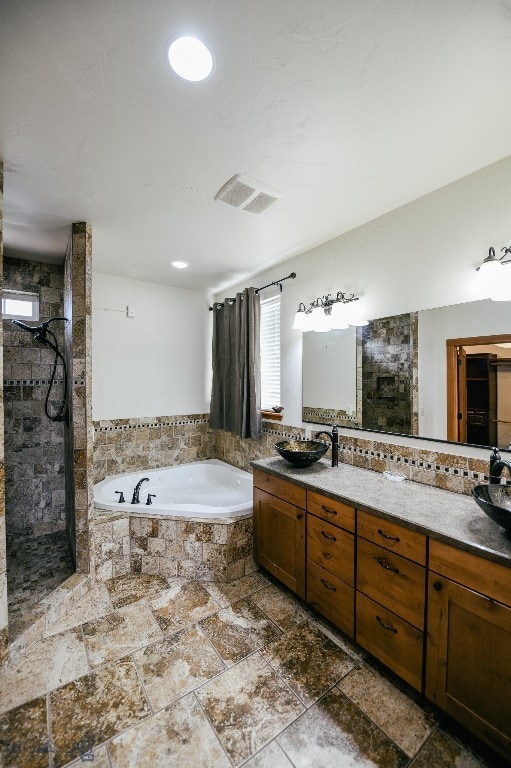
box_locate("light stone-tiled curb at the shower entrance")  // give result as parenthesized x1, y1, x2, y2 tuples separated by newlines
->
(8, 573, 94, 659)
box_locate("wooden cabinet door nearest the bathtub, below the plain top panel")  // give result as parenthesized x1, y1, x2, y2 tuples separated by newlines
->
(254, 488, 305, 599)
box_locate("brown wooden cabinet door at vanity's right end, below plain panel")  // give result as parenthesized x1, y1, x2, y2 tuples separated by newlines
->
(425, 573, 511, 759)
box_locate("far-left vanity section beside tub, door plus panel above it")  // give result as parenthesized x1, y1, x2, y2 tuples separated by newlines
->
(253, 470, 306, 598)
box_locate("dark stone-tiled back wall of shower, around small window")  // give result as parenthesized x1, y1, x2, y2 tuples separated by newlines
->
(2, 258, 65, 539)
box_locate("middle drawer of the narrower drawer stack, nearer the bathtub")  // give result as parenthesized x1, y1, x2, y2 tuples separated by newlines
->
(307, 514, 355, 587)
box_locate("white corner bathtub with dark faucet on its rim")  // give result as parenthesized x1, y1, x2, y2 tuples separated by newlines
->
(94, 459, 252, 519)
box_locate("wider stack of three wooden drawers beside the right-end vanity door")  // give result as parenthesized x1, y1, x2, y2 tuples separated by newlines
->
(355, 511, 426, 691)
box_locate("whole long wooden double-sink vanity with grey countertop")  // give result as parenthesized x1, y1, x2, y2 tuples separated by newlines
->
(252, 458, 511, 759)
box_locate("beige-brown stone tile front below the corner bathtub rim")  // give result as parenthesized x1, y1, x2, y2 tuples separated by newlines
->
(94, 510, 256, 582)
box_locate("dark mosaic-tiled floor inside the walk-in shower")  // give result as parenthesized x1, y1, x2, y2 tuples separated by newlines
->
(7, 531, 74, 638)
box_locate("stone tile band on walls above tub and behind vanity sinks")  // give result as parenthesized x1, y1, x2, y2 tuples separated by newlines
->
(94, 414, 488, 494)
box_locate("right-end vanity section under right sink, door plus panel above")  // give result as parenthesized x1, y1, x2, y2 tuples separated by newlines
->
(425, 541, 511, 760)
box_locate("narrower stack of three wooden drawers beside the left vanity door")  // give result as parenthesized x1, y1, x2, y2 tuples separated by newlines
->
(307, 491, 355, 637)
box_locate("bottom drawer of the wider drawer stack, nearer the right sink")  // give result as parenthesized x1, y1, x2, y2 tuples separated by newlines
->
(356, 592, 424, 691)
